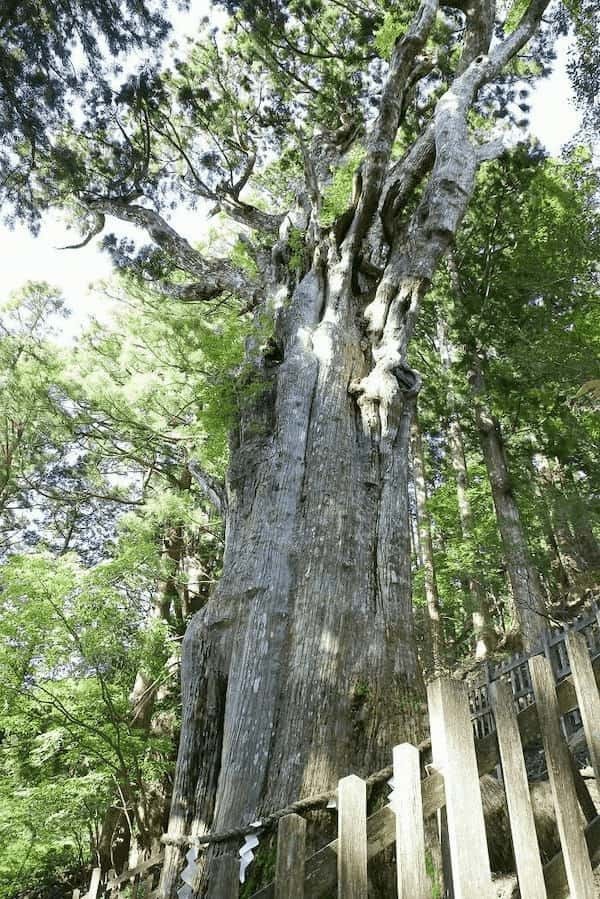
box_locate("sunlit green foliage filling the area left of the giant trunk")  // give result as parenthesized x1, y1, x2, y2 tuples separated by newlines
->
(0, 276, 250, 897)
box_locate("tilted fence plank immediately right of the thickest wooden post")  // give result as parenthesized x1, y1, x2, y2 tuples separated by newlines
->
(491, 681, 546, 899)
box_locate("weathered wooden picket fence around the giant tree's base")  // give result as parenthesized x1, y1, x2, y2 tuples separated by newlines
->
(74, 619, 600, 899)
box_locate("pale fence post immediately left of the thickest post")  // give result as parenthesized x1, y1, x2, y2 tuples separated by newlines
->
(392, 743, 431, 899)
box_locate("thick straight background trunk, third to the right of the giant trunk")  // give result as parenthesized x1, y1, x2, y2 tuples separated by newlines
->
(471, 357, 547, 648)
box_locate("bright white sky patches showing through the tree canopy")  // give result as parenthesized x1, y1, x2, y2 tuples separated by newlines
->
(0, 22, 579, 341)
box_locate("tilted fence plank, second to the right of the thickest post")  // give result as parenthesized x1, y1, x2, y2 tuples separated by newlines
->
(529, 656, 596, 899)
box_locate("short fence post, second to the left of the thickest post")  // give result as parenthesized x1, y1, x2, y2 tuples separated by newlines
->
(337, 774, 367, 899)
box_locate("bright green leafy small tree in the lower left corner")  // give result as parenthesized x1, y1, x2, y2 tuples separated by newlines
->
(0, 555, 164, 897)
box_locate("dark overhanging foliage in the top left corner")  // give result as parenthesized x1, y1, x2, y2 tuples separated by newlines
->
(0, 0, 169, 229)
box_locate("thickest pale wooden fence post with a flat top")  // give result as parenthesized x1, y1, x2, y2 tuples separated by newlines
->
(427, 679, 493, 899)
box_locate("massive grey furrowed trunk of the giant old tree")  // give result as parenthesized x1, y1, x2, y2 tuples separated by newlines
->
(157, 256, 423, 895)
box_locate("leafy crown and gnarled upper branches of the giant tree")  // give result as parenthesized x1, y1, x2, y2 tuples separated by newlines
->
(4, 0, 591, 304)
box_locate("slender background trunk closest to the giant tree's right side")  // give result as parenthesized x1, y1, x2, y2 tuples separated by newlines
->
(411, 416, 444, 675)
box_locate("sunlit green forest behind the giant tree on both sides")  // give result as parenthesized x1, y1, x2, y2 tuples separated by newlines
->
(0, 4, 600, 899)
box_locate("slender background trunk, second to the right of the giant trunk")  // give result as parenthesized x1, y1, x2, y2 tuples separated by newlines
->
(438, 317, 497, 659)
